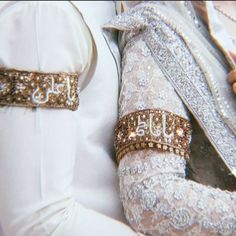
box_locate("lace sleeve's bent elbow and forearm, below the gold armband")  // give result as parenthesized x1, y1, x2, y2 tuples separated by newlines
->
(119, 152, 236, 236)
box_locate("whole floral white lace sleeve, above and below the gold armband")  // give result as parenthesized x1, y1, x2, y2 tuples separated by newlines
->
(119, 36, 236, 236)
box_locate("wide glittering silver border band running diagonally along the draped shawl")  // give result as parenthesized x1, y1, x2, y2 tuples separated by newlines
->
(139, 9, 236, 174)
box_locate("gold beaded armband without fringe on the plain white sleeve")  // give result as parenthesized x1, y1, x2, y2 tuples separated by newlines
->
(0, 68, 79, 110)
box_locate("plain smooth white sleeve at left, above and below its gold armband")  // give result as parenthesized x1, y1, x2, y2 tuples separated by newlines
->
(0, 1, 136, 236)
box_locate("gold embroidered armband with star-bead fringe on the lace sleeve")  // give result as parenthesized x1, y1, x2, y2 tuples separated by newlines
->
(115, 110, 191, 162)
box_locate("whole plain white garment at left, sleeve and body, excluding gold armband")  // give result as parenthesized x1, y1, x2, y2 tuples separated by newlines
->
(0, 1, 136, 236)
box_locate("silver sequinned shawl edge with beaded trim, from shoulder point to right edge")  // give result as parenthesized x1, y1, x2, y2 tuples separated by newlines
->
(107, 3, 236, 177)
